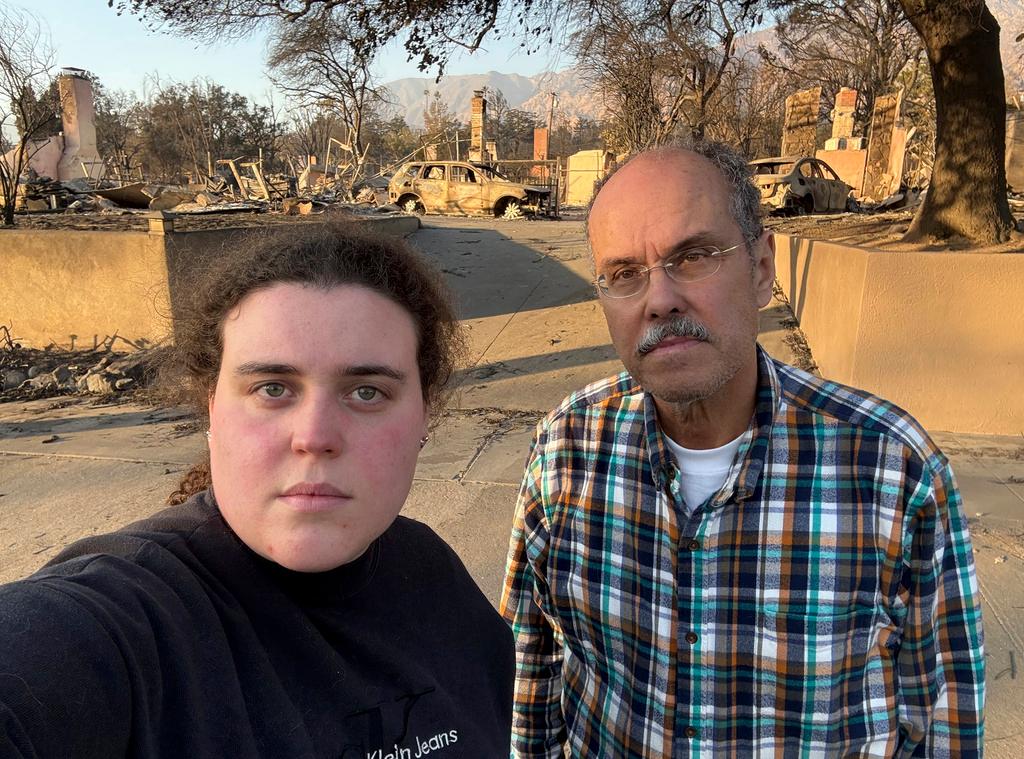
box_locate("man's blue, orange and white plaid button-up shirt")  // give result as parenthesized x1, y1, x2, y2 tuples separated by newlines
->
(501, 349, 984, 759)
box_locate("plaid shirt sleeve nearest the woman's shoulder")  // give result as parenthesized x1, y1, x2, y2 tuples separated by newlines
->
(501, 426, 566, 759)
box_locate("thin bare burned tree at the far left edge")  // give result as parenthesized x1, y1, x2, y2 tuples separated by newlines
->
(0, 5, 54, 226)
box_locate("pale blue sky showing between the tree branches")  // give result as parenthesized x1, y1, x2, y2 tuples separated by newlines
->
(18, 0, 570, 102)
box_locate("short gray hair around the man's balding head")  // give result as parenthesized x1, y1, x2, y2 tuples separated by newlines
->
(586, 138, 764, 245)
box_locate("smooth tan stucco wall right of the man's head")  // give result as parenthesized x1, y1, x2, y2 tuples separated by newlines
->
(775, 235, 1024, 434)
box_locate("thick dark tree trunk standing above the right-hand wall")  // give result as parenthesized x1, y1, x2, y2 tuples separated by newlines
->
(900, 0, 1014, 244)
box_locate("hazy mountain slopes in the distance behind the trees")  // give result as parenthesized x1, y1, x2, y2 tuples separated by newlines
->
(385, 0, 1024, 127)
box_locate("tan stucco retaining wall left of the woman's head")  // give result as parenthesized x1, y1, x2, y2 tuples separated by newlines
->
(0, 216, 420, 349)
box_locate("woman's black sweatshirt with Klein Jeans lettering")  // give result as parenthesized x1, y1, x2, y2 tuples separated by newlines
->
(0, 494, 513, 759)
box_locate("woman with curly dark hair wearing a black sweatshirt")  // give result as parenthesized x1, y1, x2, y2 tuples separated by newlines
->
(0, 225, 513, 759)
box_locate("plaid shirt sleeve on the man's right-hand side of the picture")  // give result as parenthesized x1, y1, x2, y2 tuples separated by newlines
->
(897, 463, 985, 759)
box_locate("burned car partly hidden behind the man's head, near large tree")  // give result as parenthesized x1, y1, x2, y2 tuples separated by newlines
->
(751, 158, 852, 213)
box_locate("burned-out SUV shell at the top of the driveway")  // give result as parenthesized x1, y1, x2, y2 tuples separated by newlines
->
(388, 161, 551, 218)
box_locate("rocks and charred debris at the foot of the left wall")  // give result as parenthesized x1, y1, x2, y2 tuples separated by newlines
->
(0, 331, 164, 403)
